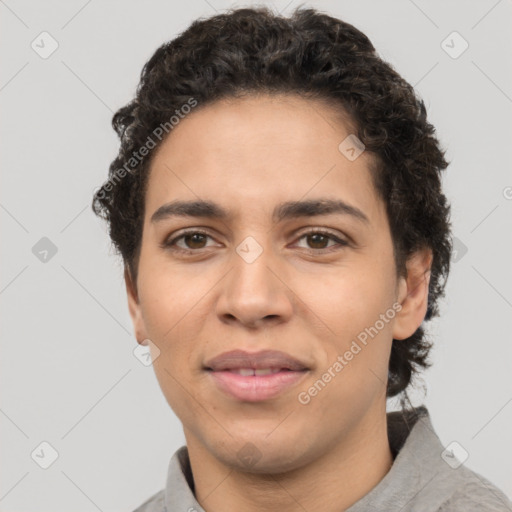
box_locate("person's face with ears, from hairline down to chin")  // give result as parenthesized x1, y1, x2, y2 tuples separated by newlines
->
(126, 96, 429, 473)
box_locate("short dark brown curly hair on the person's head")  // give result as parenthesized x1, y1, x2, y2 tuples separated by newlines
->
(92, 6, 452, 397)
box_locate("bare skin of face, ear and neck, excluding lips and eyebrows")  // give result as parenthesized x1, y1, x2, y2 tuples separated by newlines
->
(125, 95, 432, 512)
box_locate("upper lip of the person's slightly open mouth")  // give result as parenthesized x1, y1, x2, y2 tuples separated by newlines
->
(205, 350, 308, 372)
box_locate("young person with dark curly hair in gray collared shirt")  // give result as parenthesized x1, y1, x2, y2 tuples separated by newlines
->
(94, 8, 512, 512)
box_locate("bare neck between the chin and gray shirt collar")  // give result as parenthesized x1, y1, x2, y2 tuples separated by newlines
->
(185, 408, 393, 512)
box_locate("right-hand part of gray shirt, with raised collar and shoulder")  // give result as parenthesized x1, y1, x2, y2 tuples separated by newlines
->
(382, 407, 512, 512)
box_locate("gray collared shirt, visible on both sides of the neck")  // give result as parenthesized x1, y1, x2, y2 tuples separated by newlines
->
(134, 406, 512, 512)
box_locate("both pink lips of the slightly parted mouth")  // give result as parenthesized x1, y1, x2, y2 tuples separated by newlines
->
(204, 350, 309, 402)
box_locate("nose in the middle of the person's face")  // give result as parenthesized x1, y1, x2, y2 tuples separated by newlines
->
(216, 245, 293, 329)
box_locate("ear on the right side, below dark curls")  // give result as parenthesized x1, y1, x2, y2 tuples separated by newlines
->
(393, 247, 432, 340)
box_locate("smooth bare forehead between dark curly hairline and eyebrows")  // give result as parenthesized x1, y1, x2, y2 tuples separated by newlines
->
(145, 95, 382, 226)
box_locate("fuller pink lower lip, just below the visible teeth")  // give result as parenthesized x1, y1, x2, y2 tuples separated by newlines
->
(208, 370, 308, 402)
